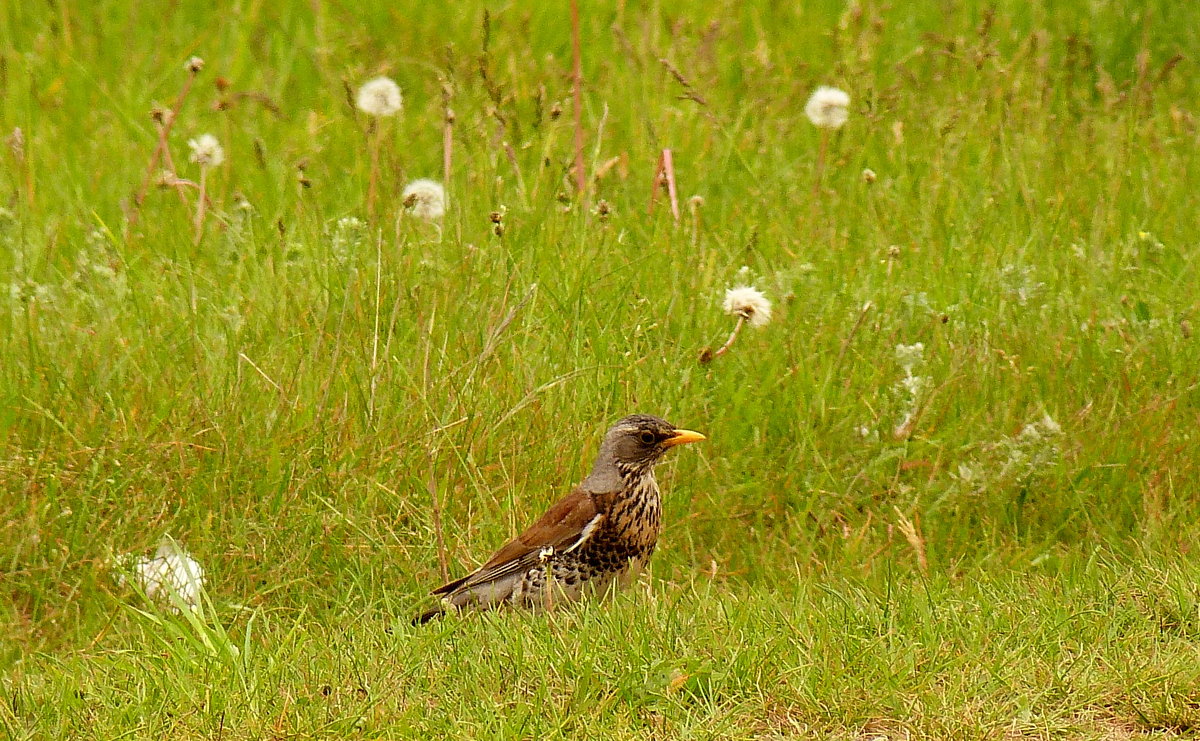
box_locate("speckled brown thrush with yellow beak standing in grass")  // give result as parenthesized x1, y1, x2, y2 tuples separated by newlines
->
(412, 414, 706, 626)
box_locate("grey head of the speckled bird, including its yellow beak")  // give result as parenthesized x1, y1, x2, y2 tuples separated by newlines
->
(584, 414, 704, 490)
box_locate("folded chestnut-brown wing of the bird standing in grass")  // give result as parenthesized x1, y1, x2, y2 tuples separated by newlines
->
(433, 489, 604, 595)
